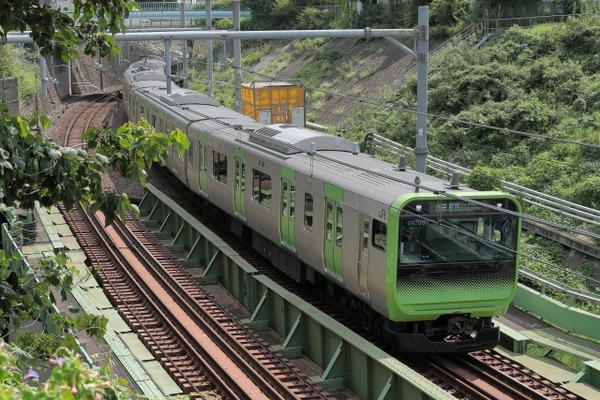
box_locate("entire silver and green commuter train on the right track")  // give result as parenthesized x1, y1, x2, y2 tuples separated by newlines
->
(123, 61, 521, 353)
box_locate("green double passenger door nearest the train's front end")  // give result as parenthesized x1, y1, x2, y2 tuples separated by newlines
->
(323, 184, 344, 280)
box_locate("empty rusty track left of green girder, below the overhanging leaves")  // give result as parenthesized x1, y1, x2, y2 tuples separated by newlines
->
(64, 207, 332, 399)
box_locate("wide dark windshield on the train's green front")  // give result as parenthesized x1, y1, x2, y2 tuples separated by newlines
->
(398, 199, 518, 269)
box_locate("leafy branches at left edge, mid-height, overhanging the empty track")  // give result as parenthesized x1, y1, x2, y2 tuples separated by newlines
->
(0, 109, 188, 223)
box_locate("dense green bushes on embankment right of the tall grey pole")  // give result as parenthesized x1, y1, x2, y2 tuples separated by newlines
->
(412, 17, 600, 207)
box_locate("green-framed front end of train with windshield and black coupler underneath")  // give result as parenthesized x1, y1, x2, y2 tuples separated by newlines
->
(384, 192, 521, 353)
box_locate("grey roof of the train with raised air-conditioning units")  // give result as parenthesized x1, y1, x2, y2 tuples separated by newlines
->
(126, 61, 473, 204)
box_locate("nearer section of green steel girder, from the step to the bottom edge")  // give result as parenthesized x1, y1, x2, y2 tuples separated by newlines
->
(248, 275, 453, 400)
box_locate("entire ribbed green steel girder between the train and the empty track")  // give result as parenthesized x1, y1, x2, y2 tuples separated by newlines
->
(139, 184, 453, 400)
